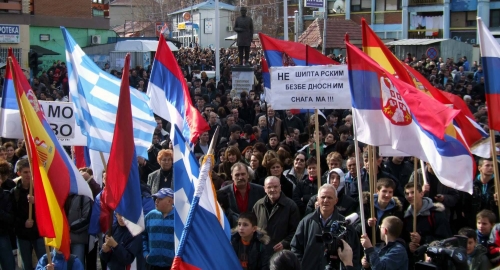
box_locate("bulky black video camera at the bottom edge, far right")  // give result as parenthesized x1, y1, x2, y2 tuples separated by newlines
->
(415, 235, 469, 270)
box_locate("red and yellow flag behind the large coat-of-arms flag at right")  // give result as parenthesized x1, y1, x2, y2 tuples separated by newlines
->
(361, 19, 490, 158)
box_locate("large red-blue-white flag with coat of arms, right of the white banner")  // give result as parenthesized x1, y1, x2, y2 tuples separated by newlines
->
(346, 42, 473, 193)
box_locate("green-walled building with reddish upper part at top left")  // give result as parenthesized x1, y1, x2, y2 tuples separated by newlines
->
(0, 0, 115, 68)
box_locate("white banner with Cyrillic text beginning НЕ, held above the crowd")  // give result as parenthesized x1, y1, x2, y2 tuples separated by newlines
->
(266, 65, 351, 110)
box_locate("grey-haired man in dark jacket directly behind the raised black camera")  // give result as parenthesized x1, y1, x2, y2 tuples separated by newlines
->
(290, 184, 361, 270)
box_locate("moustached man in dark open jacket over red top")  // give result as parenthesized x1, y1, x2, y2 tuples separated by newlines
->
(220, 162, 266, 214)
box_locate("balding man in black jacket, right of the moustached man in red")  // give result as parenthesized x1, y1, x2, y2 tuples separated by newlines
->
(253, 176, 300, 254)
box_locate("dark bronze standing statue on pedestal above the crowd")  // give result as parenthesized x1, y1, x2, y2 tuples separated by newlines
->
(234, 7, 253, 65)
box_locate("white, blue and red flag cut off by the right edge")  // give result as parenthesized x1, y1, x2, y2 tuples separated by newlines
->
(477, 17, 500, 131)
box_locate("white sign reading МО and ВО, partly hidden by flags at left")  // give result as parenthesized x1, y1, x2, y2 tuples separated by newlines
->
(0, 99, 87, 146)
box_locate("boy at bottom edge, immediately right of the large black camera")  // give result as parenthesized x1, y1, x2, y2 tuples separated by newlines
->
(458, 228, 491, 270)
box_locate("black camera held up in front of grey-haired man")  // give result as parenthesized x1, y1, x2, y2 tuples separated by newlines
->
(316, 221, 349, 269)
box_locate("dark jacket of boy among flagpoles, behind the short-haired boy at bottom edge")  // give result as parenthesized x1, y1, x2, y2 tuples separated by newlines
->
(357, 192, 404, 243)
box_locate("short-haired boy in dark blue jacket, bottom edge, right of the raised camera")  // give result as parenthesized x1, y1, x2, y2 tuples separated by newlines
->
(361, 216, 408, 270)
